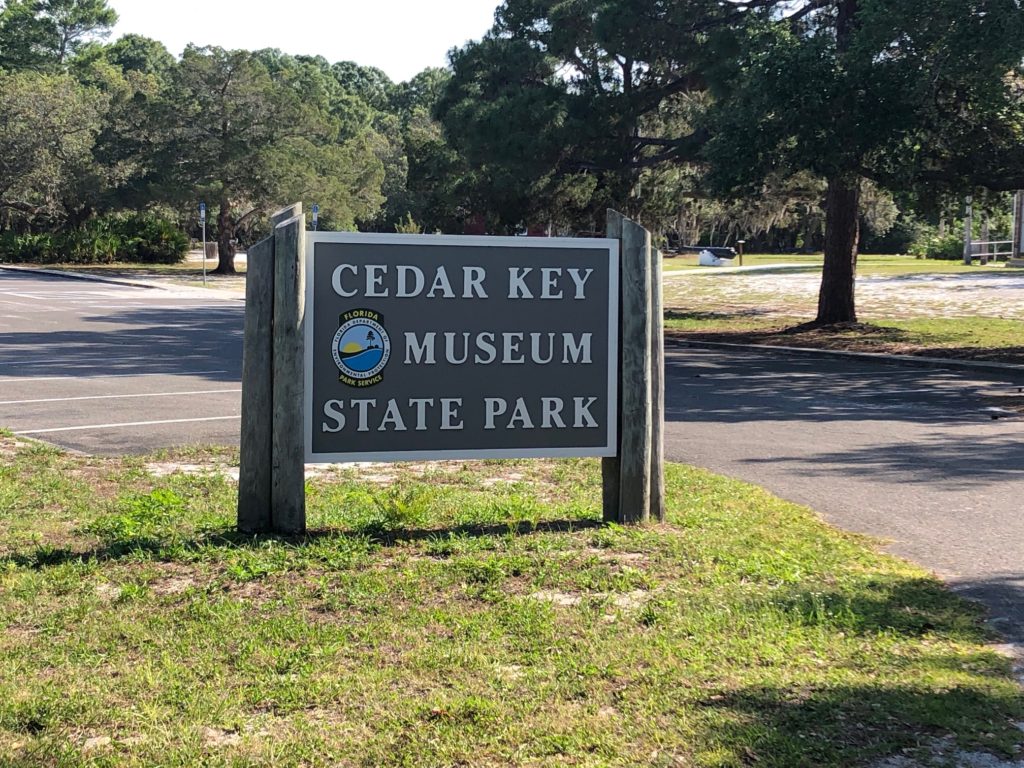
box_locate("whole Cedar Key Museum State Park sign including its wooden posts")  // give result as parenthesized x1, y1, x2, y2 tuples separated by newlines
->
(238, 204, 665, 535)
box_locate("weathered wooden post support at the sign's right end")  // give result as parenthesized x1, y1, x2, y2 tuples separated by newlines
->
(602, 211, 664, 523)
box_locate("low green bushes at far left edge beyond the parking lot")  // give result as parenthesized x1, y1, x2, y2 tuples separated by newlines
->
(0, 214, 188, 264)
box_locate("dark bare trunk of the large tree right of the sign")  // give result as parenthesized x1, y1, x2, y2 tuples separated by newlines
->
(815, 176, 860, 325)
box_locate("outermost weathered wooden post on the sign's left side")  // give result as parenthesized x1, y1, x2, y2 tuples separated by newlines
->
(238, 203, 302, 534)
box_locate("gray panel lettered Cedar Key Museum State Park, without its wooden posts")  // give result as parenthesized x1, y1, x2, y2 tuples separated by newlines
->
(305, 232, 618, 462)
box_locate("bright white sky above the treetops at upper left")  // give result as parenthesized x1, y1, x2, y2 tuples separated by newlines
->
(108, 0, 499, 82)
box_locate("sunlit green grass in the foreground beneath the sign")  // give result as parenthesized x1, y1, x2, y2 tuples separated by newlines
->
(0, 435, 1024, 768)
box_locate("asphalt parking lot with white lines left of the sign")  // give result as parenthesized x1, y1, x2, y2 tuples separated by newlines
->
(0, 269, 245, 455)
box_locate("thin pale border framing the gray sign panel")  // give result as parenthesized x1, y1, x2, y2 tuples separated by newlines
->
(302, 230, 620, 464)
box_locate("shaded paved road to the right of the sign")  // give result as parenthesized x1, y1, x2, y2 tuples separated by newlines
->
(666, 346, 1024, 642)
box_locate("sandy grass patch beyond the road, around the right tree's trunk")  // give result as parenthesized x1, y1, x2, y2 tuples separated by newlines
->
(666, 249, 1024, 365)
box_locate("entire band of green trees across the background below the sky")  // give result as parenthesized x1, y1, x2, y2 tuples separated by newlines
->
(0, 0, 1024, 309)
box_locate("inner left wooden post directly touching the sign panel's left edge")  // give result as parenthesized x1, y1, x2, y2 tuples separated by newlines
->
(270, 213, 306, 535)
